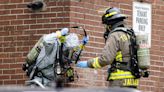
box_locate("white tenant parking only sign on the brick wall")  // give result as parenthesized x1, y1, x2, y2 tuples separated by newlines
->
(133, 2, 152, 47)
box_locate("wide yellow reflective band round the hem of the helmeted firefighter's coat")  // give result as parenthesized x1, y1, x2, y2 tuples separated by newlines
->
(109, 70, 135, 80)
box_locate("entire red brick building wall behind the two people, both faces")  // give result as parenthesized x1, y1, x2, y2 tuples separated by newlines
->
(0, 0, 164, 92)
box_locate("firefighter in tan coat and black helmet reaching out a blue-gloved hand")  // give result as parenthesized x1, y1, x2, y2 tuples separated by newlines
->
(76, 7, 139, 88)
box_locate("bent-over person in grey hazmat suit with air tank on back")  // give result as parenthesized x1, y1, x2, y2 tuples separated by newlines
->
(22, 28, 89, 88)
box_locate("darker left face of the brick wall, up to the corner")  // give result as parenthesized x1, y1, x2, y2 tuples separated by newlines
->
(0, 0, 69, 85)
